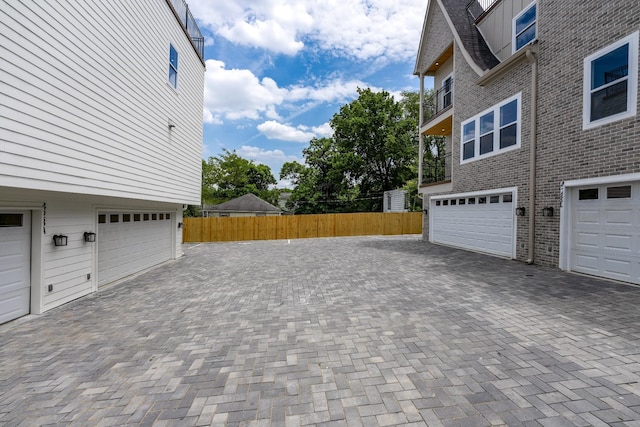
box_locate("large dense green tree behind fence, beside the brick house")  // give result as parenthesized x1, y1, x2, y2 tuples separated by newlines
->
(280, 89, 419, 213)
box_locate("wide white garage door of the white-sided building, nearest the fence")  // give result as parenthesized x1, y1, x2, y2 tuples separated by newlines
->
(96, 212, 173, 286)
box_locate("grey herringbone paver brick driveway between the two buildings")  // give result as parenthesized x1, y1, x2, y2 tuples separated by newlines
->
(0, 236, 640, 426)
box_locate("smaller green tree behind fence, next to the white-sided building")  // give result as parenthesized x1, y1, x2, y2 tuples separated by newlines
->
(202, 149, 278, 205)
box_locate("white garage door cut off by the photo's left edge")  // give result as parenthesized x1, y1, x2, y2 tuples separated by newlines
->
(0, 212, 31, 323)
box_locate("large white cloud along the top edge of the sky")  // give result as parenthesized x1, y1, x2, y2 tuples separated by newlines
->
(189, 0, 425, 60)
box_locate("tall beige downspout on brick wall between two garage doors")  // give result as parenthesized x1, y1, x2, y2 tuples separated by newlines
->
(526, 50, 538, 264)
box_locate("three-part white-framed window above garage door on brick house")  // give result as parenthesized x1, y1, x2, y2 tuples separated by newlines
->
(460, 93, 522, 164)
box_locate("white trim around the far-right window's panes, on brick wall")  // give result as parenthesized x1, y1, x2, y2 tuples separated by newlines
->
(582, 31, 638, 130)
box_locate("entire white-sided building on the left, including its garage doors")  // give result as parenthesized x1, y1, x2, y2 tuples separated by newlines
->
(0, 0, 204, 323)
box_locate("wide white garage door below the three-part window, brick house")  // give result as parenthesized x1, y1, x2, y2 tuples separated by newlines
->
(429, 192, 515, 258)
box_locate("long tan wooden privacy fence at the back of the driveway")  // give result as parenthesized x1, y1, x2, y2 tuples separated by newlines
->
(182, 212, 422, 243)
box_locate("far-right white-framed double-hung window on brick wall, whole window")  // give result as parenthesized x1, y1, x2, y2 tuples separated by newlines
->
(582, 31, 638, 130)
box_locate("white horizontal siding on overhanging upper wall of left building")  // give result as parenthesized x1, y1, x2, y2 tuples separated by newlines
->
(0, 0, 204, 204)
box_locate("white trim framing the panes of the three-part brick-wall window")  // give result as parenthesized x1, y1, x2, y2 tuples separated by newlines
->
(459, 92, 522, 165)
